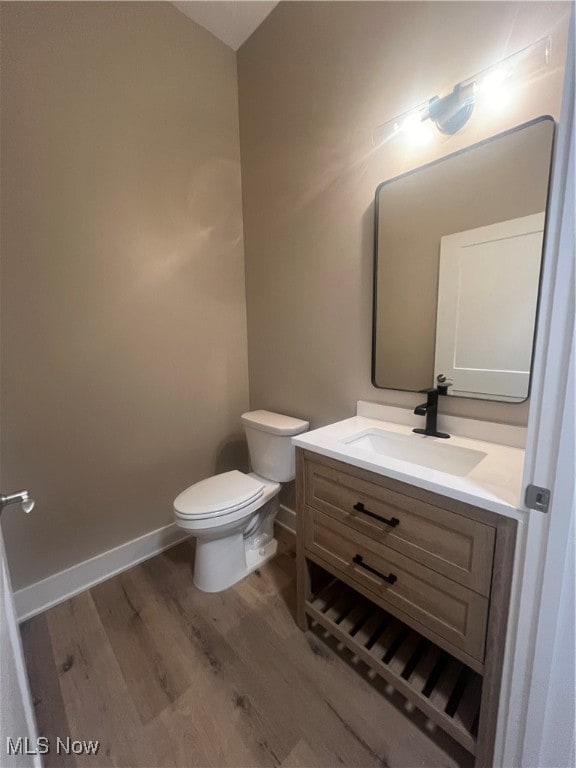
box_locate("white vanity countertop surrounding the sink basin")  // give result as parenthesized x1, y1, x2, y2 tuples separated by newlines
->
(292, 407, 524, 520)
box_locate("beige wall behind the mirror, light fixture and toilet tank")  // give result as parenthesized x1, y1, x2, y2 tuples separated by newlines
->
(238, 2, 569, 426)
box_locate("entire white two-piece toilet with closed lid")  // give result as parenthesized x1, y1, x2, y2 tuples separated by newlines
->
(174, 411, 308, 592)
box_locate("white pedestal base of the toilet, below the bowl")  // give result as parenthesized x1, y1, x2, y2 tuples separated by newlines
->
(194, 532, 278, 592)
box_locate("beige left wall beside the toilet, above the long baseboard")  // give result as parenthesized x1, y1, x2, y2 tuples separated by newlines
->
(1, 2, 248, 588)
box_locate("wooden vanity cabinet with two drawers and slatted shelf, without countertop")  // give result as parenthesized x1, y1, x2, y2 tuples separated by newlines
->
(296, 448, 516, 767)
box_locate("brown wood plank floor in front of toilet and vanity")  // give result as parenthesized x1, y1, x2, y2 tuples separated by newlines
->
(22, 542, 471, 768)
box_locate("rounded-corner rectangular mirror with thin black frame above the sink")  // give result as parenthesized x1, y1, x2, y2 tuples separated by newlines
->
(372, 117, 554, 402)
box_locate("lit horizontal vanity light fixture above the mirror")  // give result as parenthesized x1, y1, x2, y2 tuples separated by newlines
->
(372, 36, 551, 147)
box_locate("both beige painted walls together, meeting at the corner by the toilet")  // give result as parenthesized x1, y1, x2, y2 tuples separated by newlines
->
(1, 2, 567, 588)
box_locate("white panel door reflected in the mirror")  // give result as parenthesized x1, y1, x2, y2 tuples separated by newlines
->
(434, 213, 544, 401)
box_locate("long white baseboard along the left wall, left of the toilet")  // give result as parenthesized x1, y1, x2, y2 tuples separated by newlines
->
(14, 523, 190, 622)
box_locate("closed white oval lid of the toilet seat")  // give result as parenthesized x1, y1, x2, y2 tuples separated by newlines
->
(174, 469, 264, 517)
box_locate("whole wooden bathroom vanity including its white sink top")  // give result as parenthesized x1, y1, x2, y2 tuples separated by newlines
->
(294, 403, 523, 766)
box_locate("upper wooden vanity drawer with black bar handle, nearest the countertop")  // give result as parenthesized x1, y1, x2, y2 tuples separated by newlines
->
(304, 461, 495, 595)
